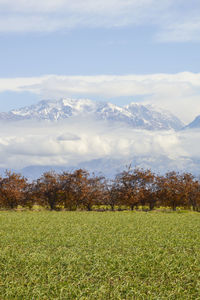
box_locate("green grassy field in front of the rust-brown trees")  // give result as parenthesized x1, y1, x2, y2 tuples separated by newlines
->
(0, 211, 200, 300)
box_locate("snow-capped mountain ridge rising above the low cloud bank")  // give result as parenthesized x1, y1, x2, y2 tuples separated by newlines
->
(0, 98, 184, 130)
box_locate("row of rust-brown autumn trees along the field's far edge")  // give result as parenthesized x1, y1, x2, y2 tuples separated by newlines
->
(0, 167, 200, 211)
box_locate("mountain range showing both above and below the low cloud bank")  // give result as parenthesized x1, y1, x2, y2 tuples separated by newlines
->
(0, 98, 200, 179)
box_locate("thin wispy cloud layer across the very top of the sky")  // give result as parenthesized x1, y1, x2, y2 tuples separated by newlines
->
(0, 0, 200, 42)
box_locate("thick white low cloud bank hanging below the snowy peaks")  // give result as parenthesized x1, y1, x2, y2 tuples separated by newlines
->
(0, 119, 200, 176)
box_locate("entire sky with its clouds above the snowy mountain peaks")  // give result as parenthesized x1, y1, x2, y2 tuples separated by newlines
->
(0, 0, 200, 122)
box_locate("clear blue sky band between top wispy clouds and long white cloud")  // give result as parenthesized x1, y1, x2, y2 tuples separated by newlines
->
(0, 26, 200, 77)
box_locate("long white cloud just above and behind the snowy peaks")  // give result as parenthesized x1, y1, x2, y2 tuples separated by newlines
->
(0, 72, 200, 123)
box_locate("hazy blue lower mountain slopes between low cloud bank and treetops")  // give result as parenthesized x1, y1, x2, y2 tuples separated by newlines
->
(0, 154, 200, 180)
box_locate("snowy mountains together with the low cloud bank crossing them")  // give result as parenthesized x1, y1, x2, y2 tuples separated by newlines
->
(0, 98, 200, 179)
